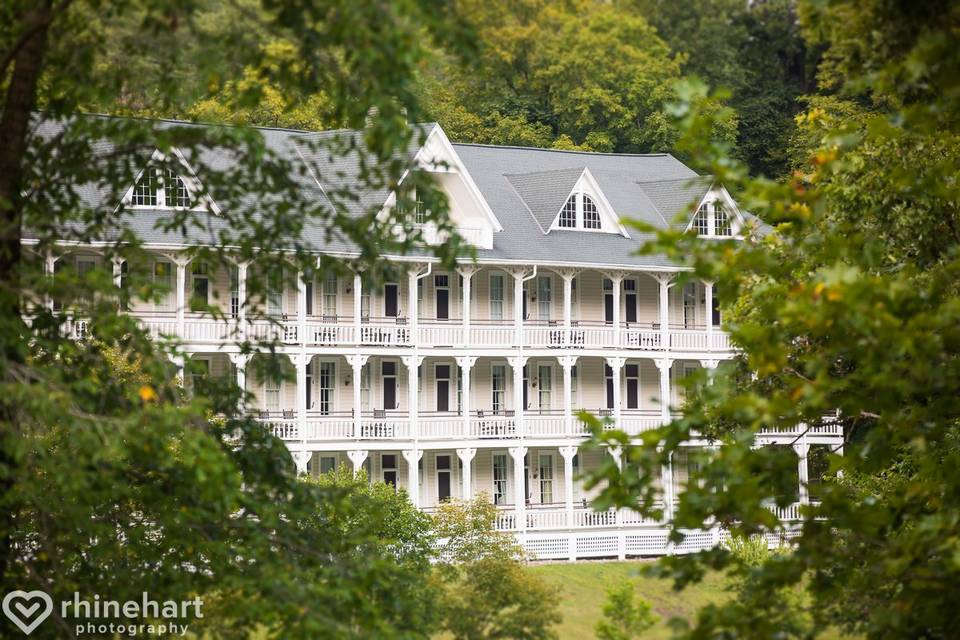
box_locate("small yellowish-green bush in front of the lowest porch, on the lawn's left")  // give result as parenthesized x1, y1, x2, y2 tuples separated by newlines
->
(434, 495, 558, 640)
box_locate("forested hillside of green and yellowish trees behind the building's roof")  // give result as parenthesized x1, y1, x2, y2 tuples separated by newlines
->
(77, 0, 817, 177)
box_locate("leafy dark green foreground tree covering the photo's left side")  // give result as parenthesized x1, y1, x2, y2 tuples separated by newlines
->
(0, 0, 476, 638)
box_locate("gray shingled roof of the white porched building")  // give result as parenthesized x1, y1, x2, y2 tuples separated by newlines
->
(26, 116, 736, 267)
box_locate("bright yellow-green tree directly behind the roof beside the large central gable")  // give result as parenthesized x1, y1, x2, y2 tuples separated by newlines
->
(422, 0, 735, 151)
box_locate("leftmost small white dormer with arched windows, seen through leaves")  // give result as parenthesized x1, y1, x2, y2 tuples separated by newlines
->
(123, 149, 220, 215)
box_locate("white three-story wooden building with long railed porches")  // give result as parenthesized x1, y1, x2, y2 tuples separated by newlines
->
(26, 120, 842, 559)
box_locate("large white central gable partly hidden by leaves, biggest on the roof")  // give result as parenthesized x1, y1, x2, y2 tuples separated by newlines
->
(381, 125, 503, 249)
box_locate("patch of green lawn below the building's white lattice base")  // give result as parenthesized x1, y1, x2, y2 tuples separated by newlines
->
(530, 561, 729, 640)
